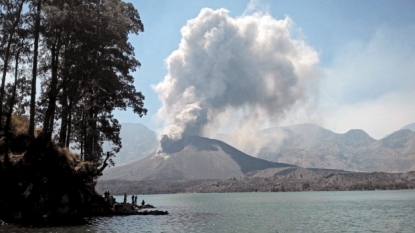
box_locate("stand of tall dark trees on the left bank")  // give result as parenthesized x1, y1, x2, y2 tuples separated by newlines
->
(0, 0, 147, 167)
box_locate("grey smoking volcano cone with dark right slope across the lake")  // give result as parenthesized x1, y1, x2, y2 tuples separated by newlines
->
(100, 136, 294, 181)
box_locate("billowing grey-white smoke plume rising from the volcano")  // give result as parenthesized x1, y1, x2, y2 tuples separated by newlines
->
(154, 8, 319, 155)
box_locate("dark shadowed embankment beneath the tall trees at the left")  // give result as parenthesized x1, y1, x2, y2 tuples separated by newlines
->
(0, 116, 109, 225)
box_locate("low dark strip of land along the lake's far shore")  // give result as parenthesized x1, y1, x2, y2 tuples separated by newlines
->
(96, 168, 415, 195)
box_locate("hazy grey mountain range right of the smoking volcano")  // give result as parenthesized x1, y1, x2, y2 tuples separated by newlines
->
(258, 124, 415, 172)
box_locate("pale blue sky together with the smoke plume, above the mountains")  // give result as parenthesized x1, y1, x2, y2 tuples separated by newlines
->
(115, 0, 415, 139)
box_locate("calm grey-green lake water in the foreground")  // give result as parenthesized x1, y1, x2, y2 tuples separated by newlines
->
(0, 190, 415, 233)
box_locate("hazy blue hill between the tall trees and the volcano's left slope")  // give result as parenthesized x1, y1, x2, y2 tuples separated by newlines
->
(104, 123, 159, 165)
